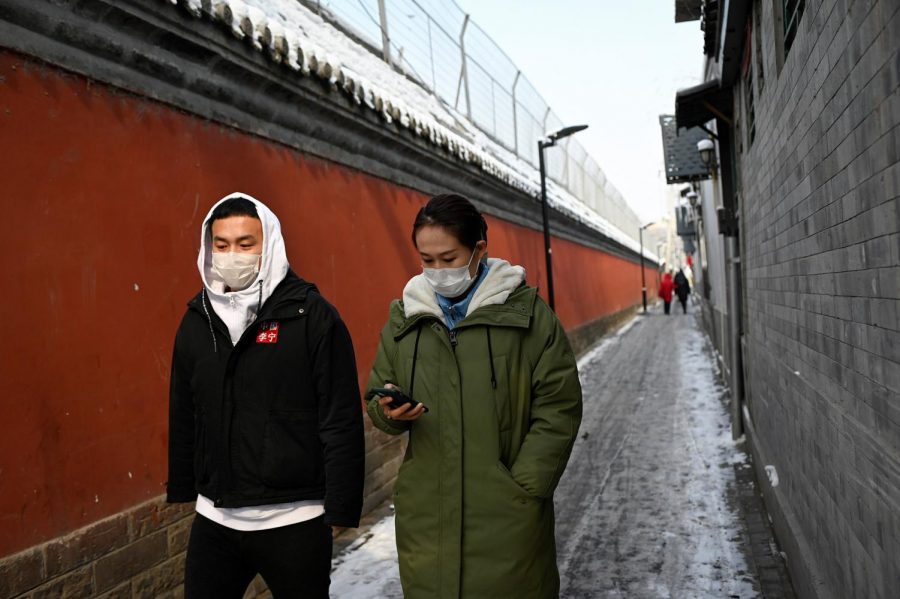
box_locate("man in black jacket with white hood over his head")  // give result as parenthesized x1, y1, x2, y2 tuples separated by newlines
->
(167, 193, 365, 599)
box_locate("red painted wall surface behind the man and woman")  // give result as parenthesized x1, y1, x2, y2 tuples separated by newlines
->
(0, 52, 655, 556)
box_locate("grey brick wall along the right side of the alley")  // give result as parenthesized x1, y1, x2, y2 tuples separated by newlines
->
(735, 0, 900, 599)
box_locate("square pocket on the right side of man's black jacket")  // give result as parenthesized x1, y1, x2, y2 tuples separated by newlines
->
(260, 410, 324, 489)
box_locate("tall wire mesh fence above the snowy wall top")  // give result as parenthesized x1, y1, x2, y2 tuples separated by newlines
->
(301, 0, 640, 244)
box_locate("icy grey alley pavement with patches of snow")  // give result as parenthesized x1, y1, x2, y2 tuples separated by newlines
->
(331, 306, 794, 599)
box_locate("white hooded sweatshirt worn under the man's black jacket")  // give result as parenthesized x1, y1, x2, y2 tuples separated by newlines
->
(197, 193, 325, 531)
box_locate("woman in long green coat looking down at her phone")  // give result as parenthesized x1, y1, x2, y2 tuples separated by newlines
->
(366, 194, 581, 599)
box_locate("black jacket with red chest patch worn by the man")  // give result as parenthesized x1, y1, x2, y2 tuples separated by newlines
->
(167, 272, 365, 527)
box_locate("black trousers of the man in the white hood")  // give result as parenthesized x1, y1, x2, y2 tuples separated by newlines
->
(184, 514, 331, 599)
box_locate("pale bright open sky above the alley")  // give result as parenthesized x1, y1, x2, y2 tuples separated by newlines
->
(456, 0, 703, 222)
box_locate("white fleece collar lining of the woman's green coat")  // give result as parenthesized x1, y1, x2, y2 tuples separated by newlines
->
(403, 258, 525, 319)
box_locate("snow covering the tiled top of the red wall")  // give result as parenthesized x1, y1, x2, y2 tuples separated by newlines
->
(163, 0, 658, 260)
